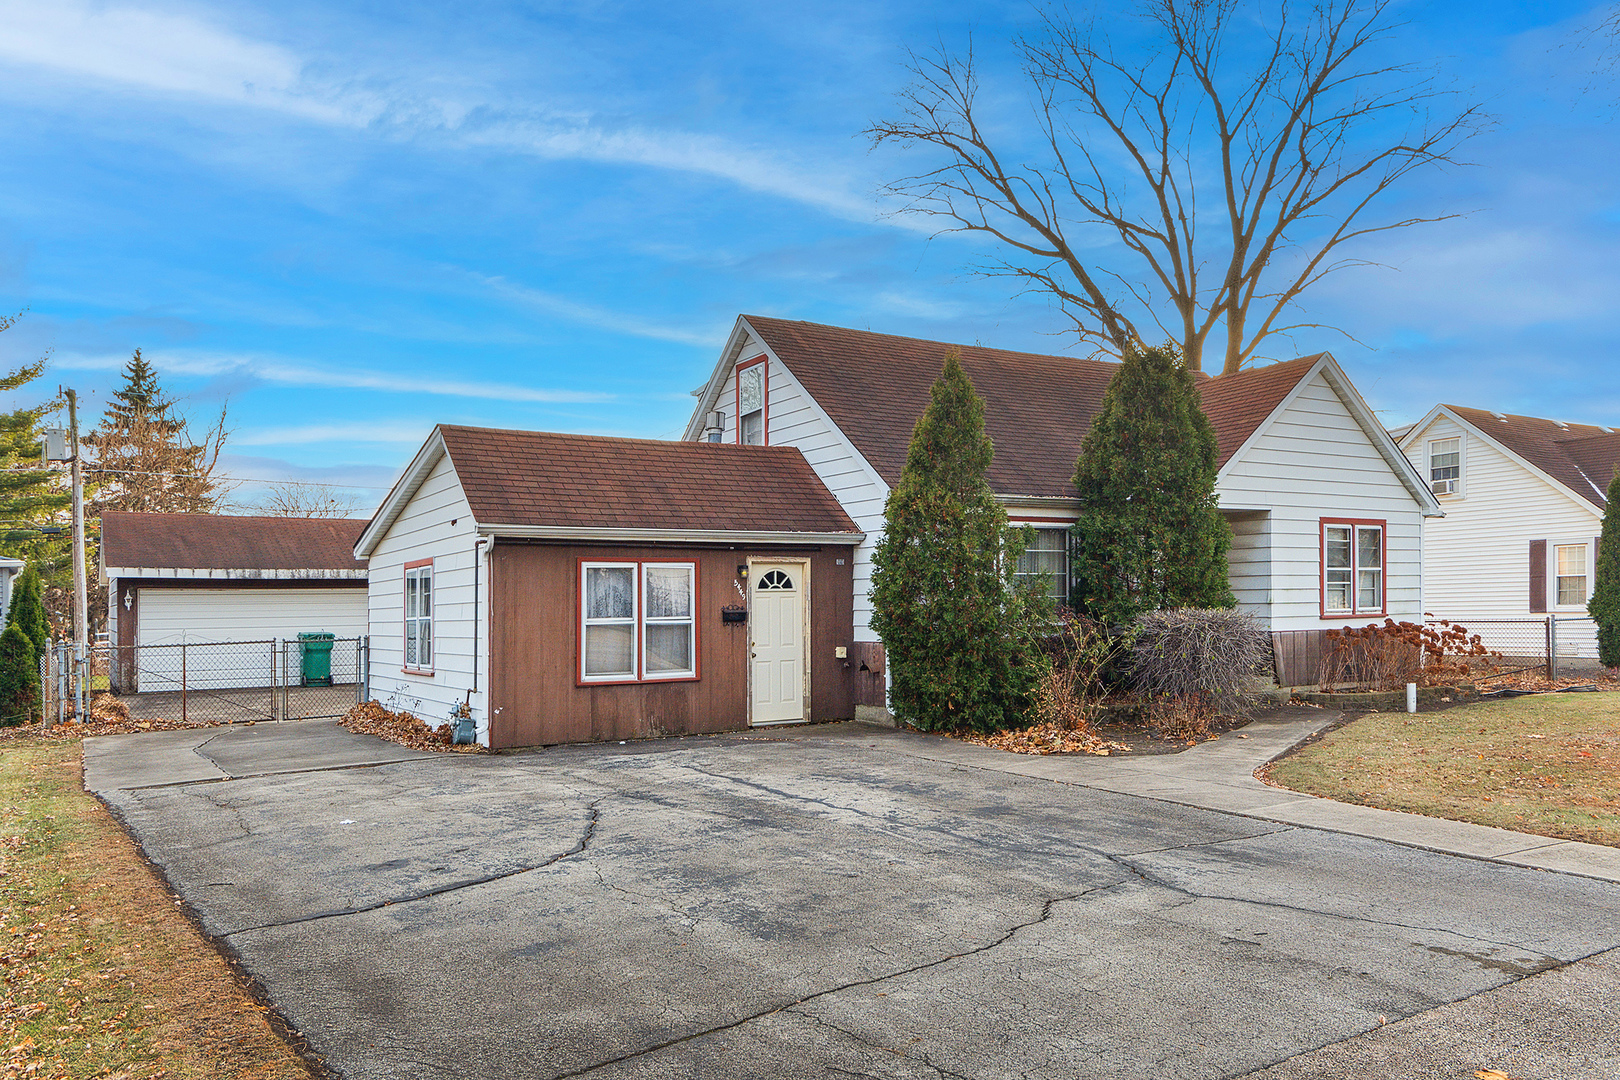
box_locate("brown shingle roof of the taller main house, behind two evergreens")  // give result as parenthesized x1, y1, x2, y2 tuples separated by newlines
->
(744, 316, 1317, 497)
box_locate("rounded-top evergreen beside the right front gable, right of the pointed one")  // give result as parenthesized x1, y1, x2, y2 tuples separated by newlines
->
(1074, 347, 1236, 623)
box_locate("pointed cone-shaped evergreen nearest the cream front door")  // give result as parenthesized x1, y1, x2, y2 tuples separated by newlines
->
(872, 350, 1053, 732)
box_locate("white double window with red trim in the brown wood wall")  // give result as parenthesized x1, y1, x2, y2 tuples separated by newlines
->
(580, 562, 698, 683)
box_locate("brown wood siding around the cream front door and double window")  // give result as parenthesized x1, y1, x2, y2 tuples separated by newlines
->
(489, 541, 854, 750)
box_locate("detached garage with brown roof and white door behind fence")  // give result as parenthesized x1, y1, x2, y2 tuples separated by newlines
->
(100, 512, 366, 691)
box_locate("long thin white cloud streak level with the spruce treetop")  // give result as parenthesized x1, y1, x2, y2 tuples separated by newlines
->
(52, 350, 614, 405)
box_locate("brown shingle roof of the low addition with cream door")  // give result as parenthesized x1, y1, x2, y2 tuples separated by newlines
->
(439, 426, 860, 533)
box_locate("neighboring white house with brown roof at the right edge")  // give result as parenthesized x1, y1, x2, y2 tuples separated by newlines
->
(1398, 405, 1620, 656)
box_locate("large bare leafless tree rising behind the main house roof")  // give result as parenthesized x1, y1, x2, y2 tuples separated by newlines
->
(867, 0, 1484, 372)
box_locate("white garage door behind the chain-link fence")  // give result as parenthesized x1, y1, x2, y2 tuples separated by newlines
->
(138, 588, 366, 644)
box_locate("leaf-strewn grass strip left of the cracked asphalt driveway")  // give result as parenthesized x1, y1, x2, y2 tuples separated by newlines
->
(0, 738, 309, 1080)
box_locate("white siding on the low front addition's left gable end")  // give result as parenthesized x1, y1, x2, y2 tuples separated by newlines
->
(368, 457, 489, 745)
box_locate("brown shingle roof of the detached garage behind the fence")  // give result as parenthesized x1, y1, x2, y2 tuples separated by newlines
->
(100, 510, 366, 570)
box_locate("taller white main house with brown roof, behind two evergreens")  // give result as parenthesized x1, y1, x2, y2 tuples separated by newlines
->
(685, 316, 1442, 641)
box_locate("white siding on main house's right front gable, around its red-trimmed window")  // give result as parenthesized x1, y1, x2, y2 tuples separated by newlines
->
(1217, 372, 1424, 630)
